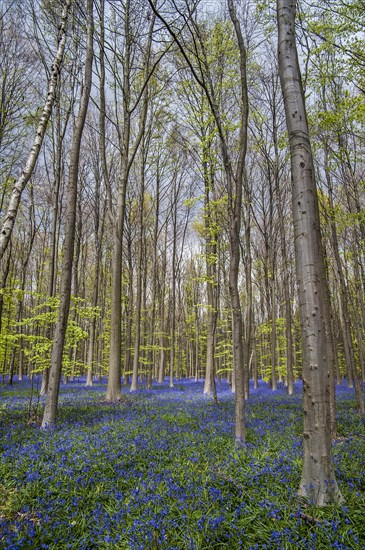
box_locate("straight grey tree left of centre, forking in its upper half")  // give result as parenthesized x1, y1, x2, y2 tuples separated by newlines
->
(106, 0, 154, 401)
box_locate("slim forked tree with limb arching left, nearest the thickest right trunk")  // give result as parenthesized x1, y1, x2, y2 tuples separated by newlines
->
(149, 0, 248, 447)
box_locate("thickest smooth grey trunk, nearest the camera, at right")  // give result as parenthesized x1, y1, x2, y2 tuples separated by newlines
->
(277, 0, 342, 506)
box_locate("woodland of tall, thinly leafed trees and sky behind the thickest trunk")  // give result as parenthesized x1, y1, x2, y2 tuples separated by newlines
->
(0, 0, 365, 524)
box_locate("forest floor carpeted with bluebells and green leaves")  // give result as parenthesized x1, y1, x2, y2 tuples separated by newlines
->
(0, 380, 365, 550)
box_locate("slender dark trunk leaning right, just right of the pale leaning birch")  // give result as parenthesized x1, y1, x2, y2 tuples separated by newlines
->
(42, 0, 94, 428)
